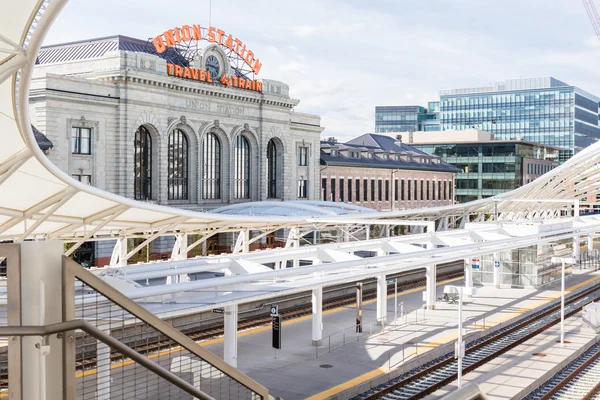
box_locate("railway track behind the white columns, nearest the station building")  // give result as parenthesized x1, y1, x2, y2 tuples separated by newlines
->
(0, 267, 464, 390)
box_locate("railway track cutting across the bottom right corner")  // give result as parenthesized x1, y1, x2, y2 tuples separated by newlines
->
(524, 343, 600, 400)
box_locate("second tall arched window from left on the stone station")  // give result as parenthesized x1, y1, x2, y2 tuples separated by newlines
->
(167, 129, 188, 200)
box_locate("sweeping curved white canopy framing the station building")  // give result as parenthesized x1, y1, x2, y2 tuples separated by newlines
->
(0, 0, 600, 243)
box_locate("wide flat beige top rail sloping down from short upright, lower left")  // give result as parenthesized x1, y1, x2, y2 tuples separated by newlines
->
(63, 256, 269, 400)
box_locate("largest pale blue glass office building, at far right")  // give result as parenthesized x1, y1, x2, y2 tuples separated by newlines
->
(439, 78, 600, 162)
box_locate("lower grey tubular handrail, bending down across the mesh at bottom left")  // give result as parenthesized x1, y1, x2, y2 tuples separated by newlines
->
(0, 319, 215, 400)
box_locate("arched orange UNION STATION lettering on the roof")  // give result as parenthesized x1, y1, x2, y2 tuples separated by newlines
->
(152, 24, 262, 78)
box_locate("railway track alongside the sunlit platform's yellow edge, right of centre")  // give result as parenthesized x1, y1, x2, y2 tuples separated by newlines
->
(354, 278, 600, 400)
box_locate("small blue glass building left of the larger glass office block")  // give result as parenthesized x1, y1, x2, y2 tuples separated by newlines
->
(375, 102, 440, 133)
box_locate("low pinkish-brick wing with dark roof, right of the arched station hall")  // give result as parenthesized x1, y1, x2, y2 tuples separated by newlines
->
(321, 134, 458, 211)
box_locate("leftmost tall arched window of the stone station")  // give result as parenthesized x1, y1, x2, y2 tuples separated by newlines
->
(134, 126, 152, 200)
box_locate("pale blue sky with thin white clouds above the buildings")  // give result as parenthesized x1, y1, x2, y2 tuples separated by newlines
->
(45, 0, 600, 140)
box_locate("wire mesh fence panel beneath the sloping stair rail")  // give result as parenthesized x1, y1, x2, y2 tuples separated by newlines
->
(75, 281, 262, 400)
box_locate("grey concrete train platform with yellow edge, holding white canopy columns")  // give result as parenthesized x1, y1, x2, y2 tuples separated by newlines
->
(198, 270, 600, 400)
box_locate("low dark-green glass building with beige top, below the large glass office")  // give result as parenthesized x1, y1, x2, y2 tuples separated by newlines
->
(406, 129, 560, 203)
